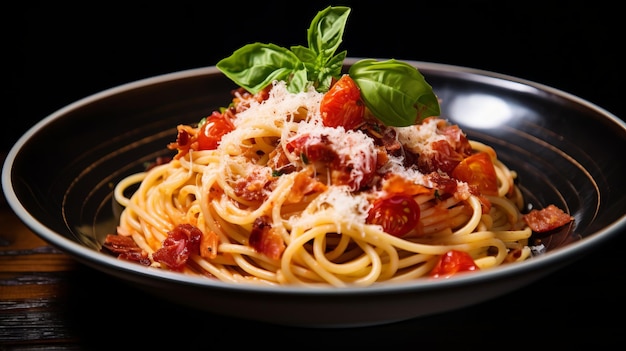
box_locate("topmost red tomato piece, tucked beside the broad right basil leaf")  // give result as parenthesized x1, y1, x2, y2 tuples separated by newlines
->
(320, 75, 365, 130)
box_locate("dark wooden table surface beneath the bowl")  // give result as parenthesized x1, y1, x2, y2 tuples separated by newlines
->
(0, 184, 626, 351)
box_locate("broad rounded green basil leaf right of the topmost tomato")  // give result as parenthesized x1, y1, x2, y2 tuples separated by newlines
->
(349, 59, 440, 127)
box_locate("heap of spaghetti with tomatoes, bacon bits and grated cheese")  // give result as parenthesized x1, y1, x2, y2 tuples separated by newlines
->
(105, 80, 532, 287)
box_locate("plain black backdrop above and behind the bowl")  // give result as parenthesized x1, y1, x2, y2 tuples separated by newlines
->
(7, 0, 625, 149)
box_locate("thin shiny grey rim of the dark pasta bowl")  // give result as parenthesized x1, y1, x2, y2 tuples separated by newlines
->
(1, 57, 626, 295)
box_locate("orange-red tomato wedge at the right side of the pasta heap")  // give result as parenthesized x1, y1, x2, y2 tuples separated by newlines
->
(450, 152, 498, 196)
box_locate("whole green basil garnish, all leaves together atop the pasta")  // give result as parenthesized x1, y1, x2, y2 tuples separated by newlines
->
(216, 6, 440, 127)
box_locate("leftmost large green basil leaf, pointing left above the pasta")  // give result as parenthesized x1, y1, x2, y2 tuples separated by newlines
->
(216, 43, 304, 94)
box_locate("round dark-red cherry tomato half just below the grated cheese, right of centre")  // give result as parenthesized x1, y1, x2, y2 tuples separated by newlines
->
(367, 194, 420, 237)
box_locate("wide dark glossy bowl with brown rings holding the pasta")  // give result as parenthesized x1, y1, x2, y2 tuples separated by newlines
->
(2, 58, 626, 328)
